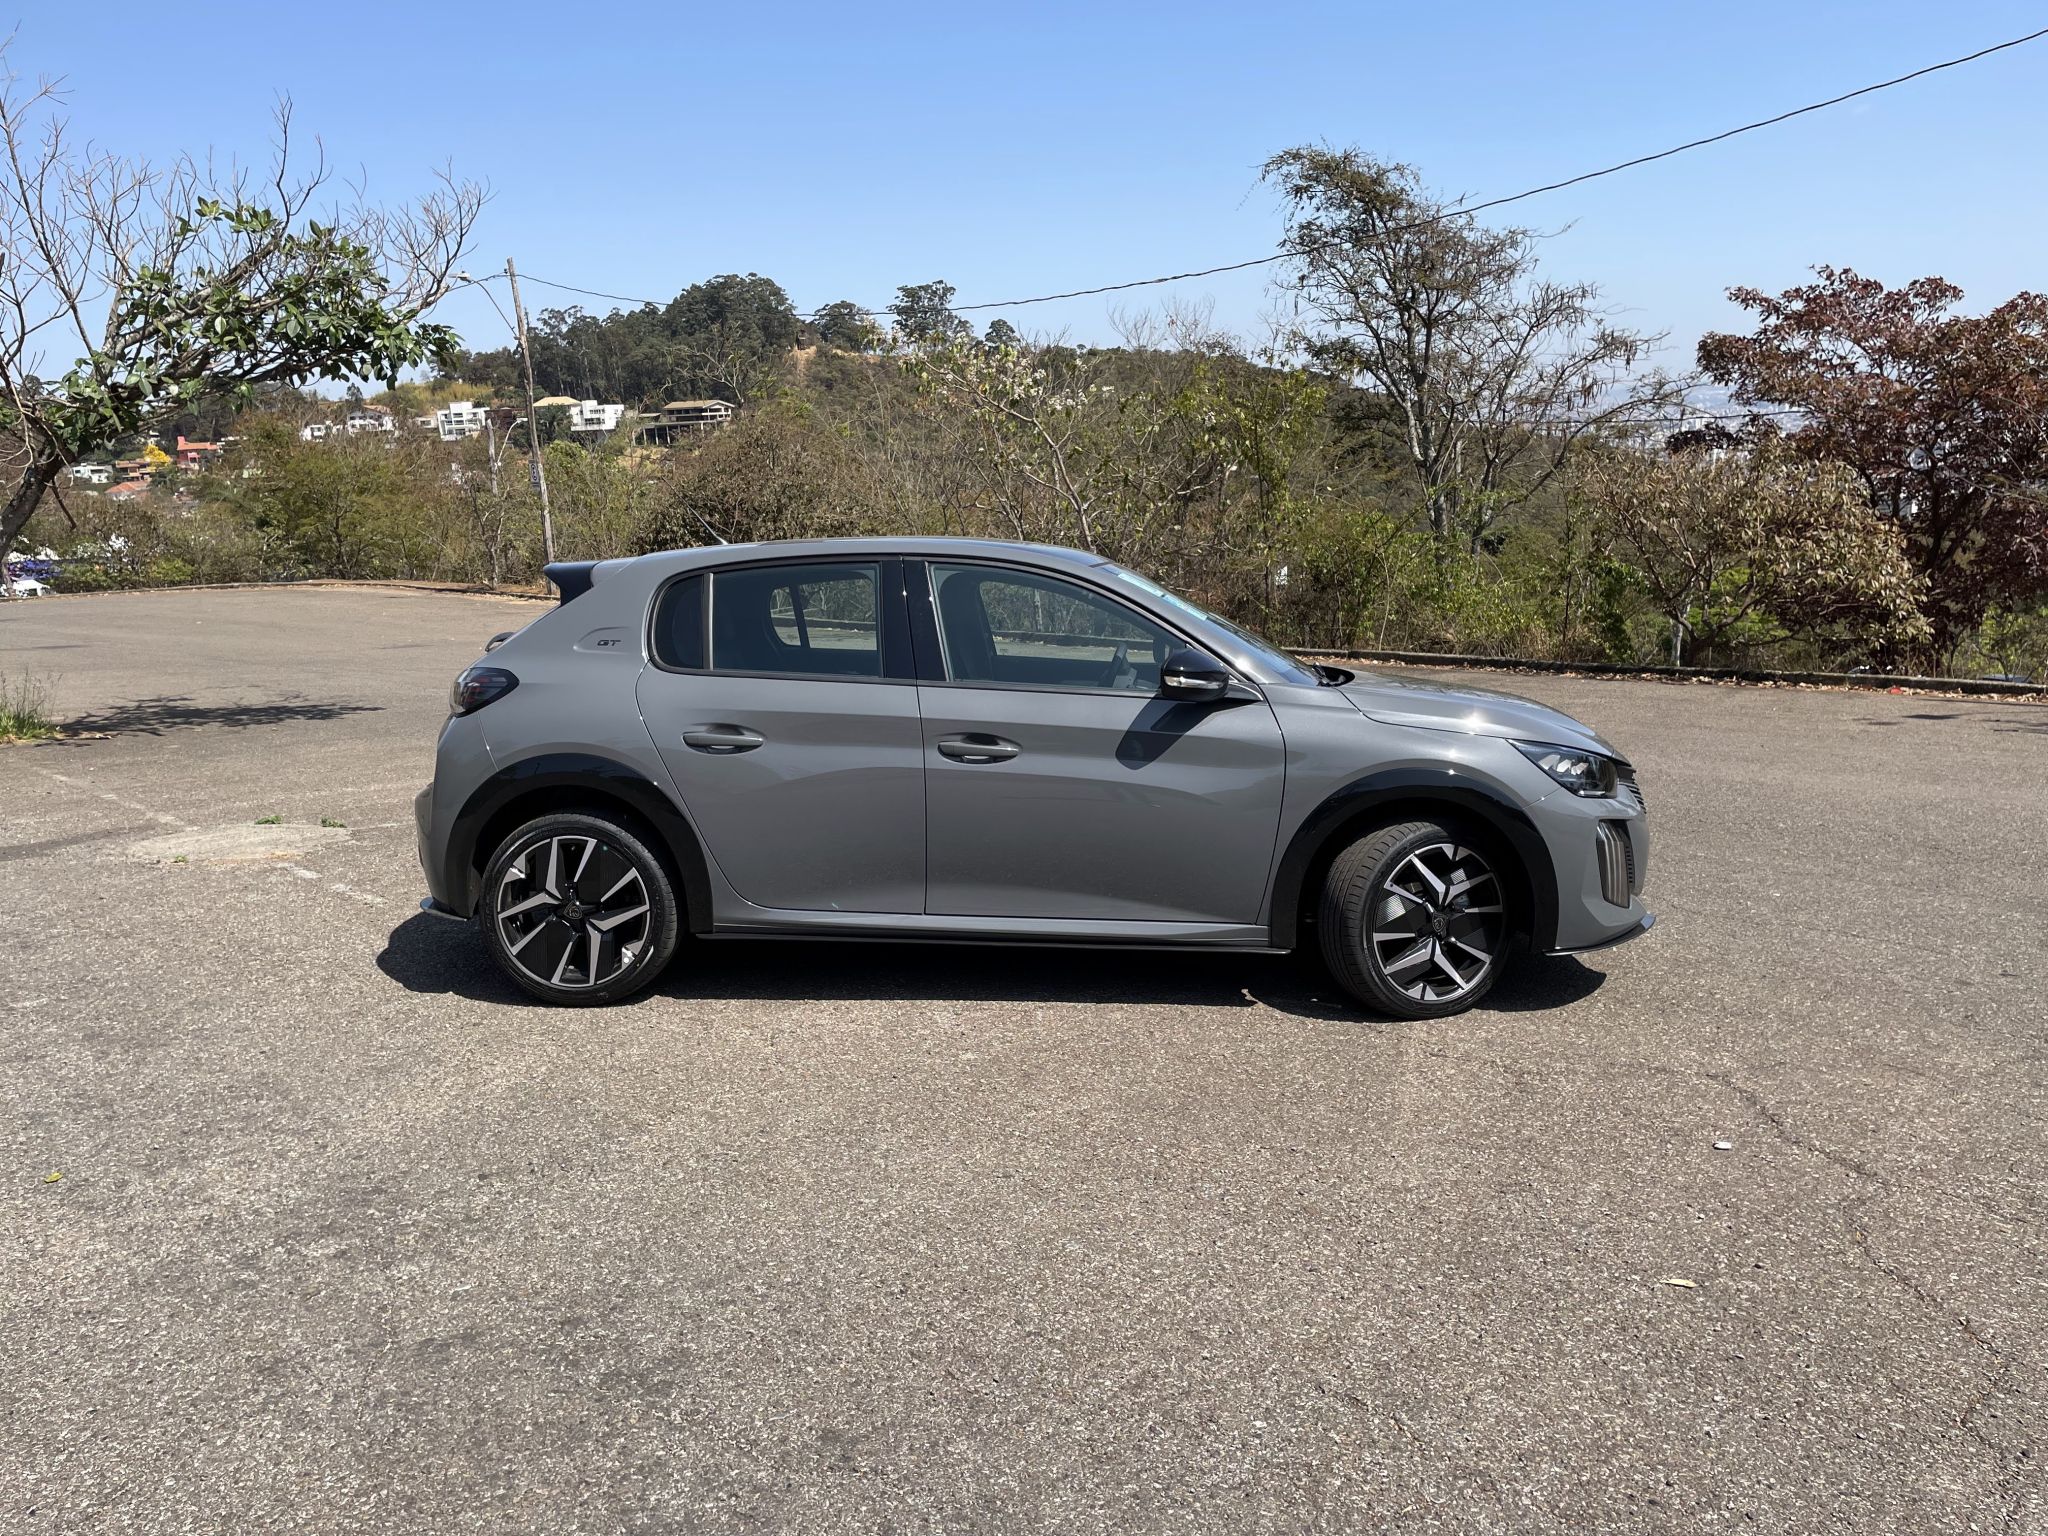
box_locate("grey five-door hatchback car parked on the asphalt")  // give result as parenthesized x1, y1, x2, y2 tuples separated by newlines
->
(416, 539, 1653, 1018)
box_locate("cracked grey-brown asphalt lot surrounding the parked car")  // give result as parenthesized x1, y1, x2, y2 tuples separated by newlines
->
(0, 590, 2048, 1536)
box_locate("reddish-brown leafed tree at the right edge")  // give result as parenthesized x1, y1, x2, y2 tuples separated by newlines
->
(1700, 266, 2048, 653)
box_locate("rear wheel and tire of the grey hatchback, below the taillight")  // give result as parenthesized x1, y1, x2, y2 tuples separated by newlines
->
(477, 811, 682, 1008)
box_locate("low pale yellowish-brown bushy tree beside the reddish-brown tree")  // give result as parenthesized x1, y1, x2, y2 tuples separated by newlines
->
(1573, 440, 1927, 664)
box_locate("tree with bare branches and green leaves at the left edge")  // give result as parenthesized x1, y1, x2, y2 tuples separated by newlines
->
(0, 49, 483, 573)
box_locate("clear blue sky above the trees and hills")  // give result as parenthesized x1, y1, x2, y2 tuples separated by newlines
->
(12, 0, 2048, 376)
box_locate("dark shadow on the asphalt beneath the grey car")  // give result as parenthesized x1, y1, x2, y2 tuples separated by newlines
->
(377, 913, 1606, 1022)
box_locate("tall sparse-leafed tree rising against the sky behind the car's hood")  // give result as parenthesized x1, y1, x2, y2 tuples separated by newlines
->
(1264, 147, 1665, 551)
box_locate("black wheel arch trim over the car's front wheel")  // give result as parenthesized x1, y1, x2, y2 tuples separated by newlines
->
(1268, 768, 1556, 952)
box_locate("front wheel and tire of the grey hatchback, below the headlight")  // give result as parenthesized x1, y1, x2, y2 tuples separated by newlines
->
(1317, 821, 1509, 1018)
